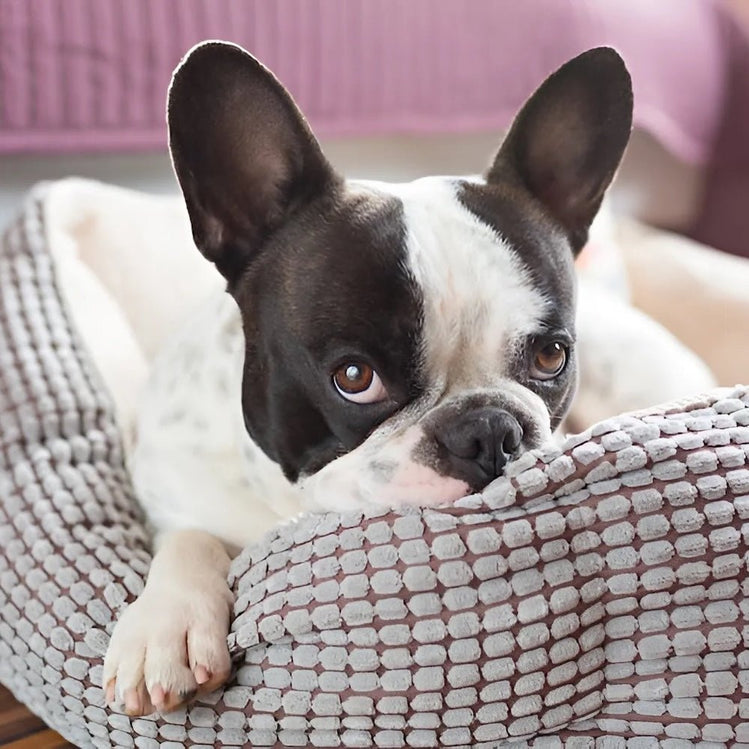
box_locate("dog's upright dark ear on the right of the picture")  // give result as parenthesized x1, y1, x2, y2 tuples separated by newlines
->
(486, 47, 632, 253)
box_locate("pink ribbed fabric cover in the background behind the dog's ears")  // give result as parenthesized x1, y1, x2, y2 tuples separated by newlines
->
(0, 0, 726, 160)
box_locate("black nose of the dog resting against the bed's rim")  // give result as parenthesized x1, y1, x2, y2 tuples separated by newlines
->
(434, 406, 523, 489)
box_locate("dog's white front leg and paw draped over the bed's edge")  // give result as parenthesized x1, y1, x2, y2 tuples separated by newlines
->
(102, 530, 233, 715)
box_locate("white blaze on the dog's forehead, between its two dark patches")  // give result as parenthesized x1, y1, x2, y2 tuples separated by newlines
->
(370, 177, 548, 392)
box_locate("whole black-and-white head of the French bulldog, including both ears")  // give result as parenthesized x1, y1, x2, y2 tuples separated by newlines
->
(168, 42, 632, 508)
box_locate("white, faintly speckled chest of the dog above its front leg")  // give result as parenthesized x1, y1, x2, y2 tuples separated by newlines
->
(132, 294, 301, 545)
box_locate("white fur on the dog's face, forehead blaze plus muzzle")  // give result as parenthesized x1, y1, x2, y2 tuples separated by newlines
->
(302, 177, 551, 510)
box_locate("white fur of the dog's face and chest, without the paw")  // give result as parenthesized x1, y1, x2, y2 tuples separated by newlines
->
(127, 177, 549, 524)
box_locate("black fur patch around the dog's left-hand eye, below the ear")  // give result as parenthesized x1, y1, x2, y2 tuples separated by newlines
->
(233, 189, 423, 481)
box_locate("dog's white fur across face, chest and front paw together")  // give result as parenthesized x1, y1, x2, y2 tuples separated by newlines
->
(104, 178, 560, 712)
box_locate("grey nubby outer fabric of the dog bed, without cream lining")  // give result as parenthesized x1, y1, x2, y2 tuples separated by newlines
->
(0, 183, 749, 748)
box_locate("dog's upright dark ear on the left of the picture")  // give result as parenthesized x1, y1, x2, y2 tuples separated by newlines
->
(167, 42, 338, 284)
